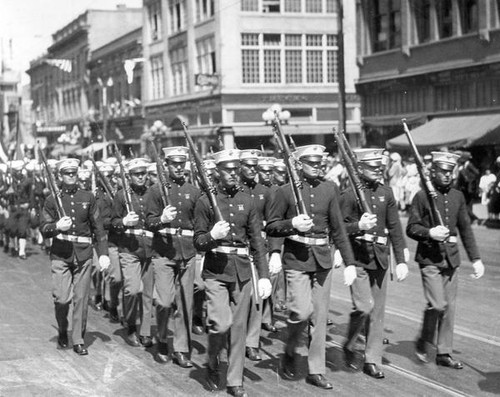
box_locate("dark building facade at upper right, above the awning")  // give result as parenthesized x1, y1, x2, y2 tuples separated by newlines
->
(356, 0, 500, 161)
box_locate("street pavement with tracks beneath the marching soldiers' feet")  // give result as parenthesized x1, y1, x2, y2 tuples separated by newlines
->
(0, 213, 500, 397)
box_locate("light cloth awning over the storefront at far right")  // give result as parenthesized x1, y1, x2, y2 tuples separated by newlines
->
(387, 114, 500, 150)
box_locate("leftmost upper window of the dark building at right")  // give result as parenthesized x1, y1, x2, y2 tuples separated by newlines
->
(372, 0, 401, 52)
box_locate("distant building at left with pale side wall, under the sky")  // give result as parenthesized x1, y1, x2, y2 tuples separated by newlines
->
(27, 6, 142, 152)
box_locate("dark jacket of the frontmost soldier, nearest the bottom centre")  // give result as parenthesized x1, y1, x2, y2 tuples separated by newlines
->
(194, 187, 269, 282)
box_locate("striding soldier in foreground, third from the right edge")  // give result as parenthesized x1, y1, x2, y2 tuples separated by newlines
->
(266, 145, 355, 389)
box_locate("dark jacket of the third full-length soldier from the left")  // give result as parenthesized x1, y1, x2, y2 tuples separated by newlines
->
(146, 180, 201, 260)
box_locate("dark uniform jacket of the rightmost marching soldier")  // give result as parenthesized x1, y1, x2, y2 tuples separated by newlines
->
(406, 188, 480, 267)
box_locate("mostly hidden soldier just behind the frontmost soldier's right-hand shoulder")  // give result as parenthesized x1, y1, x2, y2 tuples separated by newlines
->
(240, 149, 280, 361)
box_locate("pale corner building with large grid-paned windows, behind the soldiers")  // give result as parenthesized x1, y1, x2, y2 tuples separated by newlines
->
(143, 0, 360, 154)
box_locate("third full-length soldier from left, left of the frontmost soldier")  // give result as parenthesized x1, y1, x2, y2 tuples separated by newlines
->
(147, 146, 201, 368)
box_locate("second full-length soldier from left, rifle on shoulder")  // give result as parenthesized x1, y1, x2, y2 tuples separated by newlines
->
(111, 158, 153, 347)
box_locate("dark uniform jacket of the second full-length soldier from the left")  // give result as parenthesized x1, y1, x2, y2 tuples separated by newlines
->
(111, 186, 153, 259)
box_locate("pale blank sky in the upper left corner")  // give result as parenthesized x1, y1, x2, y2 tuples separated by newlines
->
(0, 0, 142, 84)
